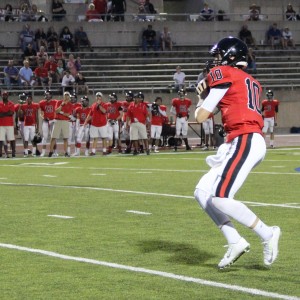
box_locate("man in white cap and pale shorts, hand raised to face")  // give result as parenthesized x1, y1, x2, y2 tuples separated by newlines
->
(84, 92, 108, 156)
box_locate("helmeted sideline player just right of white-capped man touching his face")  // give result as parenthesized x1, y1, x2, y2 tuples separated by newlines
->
(107, 93, 123, 153)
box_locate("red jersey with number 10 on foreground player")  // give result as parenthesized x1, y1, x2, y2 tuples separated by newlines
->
(207, 66, 264, 142)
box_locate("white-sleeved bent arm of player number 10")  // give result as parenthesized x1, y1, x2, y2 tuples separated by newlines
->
(195, 87, 229, 123)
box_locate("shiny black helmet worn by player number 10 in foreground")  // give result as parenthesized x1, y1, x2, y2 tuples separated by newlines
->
(209, 36, 248, 67)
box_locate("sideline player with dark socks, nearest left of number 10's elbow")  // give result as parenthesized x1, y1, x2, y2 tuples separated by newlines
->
(170, 89, 192, 151)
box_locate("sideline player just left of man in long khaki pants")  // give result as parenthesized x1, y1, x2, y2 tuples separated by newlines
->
(39, 90, 58, 157)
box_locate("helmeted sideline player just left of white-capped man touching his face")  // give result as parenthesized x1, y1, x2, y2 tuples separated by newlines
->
(73, 96, 91, 156)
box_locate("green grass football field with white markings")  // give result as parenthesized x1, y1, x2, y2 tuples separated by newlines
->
(0, 148, 300, 300)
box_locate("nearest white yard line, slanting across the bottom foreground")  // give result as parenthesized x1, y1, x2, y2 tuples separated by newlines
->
(0, 243, 300, 300)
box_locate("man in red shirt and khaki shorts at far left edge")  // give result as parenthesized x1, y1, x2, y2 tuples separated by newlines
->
(0, 91, 16, 157)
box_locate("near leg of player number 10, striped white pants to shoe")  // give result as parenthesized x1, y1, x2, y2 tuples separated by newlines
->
(212, 133, 280, 264)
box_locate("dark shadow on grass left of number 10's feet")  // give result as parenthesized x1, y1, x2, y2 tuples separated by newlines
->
(138, 240, 215, 268)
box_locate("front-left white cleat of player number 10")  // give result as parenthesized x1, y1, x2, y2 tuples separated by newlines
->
(218, 238, 250, 269)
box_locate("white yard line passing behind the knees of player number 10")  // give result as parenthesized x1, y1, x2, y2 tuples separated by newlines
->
(0, 182, 300, 209)
